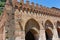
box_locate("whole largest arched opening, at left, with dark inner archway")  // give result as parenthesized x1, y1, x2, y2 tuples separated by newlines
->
(25, 19, 40, 40)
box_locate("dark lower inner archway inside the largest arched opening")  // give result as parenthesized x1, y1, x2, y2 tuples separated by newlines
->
(25, 29, 39, 40)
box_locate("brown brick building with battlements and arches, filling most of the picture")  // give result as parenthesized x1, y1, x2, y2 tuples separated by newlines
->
(0, 0, 60, 40)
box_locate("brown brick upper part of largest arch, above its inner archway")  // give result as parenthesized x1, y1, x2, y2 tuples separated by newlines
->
(25, 18, 40, 31)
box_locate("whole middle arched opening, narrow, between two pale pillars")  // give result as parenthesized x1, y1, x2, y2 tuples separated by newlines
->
(45, 20, 53, 40)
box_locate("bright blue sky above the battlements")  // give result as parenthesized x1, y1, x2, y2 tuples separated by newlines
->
(17, 0, 60, 8)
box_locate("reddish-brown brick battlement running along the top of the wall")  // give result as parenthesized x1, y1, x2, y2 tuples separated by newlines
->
(5, 0, 60, 17)
